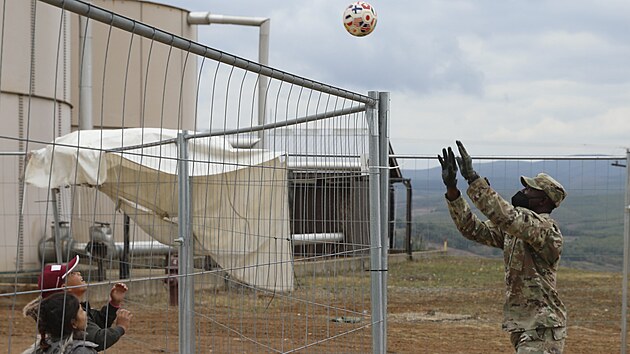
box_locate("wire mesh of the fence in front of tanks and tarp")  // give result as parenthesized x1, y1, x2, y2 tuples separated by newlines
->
(0, 1, 374, 353)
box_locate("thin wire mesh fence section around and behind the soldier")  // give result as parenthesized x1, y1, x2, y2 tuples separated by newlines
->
(389, 155, 627, 353)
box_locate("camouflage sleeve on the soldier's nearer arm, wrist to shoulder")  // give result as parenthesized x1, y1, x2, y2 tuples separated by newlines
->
(468, 178, 562, 264)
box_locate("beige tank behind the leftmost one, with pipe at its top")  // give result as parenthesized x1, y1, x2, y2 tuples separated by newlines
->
(72, 0, 197, 130)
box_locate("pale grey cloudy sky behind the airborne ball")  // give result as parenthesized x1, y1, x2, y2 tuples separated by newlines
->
(161, 0, 630, 155)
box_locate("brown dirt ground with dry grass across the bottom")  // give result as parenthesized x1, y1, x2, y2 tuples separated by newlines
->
(0, 257, 621, 354)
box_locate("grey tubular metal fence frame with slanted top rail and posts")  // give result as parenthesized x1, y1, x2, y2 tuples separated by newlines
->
(22, 0, 396, 353)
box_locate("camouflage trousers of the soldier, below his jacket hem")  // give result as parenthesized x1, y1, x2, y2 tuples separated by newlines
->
(510, 327, 567, 354)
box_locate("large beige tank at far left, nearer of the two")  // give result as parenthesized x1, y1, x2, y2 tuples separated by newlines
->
(0, 0, 72, 271)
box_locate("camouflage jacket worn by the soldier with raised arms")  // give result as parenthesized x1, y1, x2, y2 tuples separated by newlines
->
(447, 178, 566, 332)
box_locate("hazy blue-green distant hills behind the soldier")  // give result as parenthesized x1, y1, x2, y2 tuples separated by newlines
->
(395, 160, 626, 271)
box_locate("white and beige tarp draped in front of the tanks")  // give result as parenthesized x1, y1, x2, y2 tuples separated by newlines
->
(25, 128, 293, 291)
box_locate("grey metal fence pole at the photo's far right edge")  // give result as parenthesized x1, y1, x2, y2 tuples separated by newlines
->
(621, 150, 630, 354)
